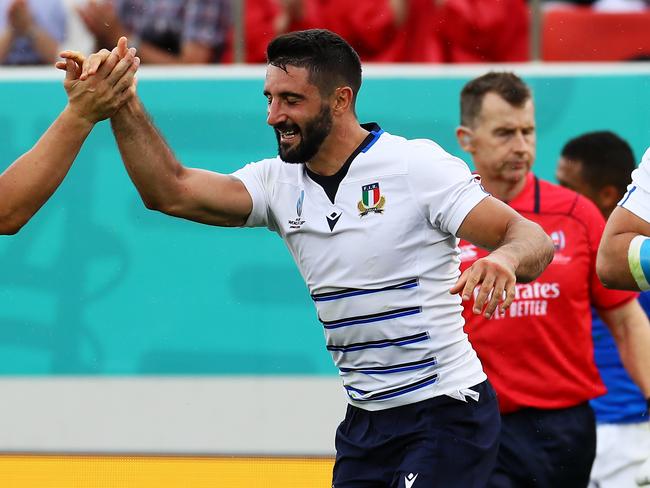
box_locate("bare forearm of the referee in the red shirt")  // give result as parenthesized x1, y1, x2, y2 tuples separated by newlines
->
(598, 300, 650, 398)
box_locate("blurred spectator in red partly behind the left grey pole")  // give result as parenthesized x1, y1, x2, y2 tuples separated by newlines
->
(223, 0, 322, 63)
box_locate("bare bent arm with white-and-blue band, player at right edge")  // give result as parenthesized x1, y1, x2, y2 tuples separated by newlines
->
(596, 207, 650, 290)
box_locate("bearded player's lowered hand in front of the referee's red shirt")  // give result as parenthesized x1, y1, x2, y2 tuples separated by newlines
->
(449, 251, 517, 318)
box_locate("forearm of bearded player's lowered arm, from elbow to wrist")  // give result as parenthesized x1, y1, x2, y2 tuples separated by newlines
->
(492, 218, 553, 283)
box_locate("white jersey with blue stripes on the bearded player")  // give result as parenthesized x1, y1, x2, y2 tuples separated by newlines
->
(233, 125, 487, 410)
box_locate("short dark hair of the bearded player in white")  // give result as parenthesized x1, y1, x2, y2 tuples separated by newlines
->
(266, 29, 361, 107)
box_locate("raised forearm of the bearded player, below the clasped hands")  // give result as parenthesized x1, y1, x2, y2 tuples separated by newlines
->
(111, 98, 183, 212)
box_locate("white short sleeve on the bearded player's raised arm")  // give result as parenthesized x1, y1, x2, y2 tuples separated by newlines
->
(231, 160, 275, 230)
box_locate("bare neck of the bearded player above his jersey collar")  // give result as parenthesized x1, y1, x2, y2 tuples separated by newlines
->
(307, 120, 368, 176)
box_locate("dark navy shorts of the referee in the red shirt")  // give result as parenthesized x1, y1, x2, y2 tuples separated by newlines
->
(489, 403, 596, 488)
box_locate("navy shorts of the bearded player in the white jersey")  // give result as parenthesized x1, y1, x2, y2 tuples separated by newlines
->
(332, 381, 501, 488)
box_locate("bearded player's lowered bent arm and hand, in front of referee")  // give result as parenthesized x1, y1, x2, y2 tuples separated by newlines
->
(451, 197, 554, 317)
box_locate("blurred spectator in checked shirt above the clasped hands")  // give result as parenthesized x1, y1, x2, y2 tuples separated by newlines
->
(77, 0, 231, 63)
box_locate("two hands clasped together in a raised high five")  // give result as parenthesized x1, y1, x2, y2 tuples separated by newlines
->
(56, 37, 140, 124)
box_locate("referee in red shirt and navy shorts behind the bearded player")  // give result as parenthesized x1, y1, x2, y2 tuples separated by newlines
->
(457, 72, 650, 488)
